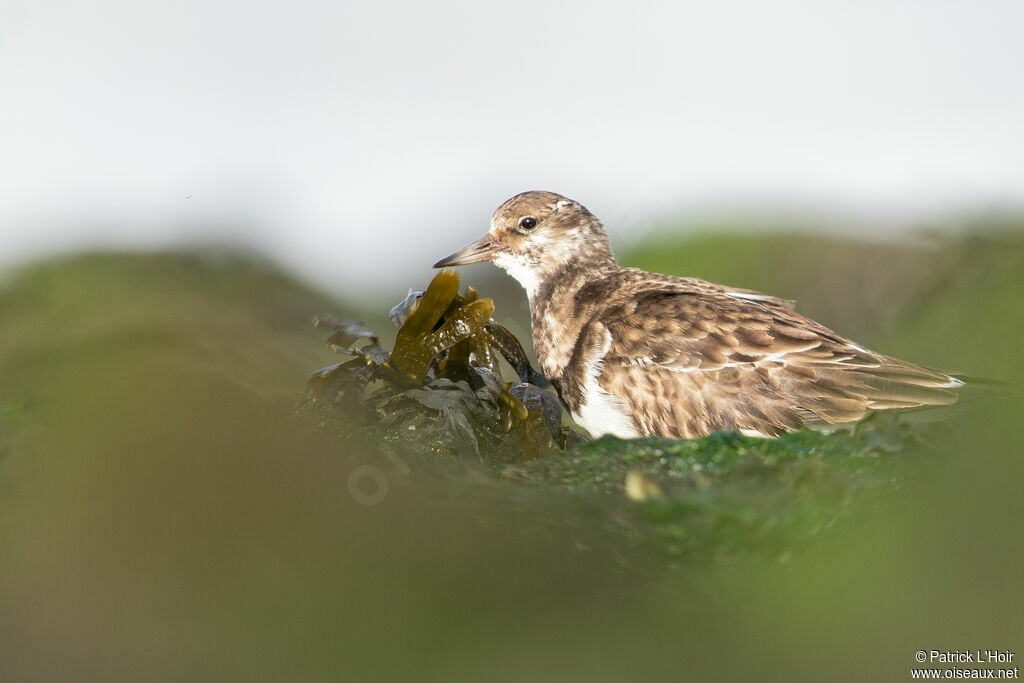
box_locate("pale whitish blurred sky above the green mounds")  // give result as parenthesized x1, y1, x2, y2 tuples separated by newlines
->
(0, 0, 1024, 288)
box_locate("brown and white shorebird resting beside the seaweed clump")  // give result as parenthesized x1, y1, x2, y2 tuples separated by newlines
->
(434, 190, 965, 438)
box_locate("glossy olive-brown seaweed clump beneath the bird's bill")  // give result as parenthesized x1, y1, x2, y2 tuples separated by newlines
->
(306, 270, 581, 462)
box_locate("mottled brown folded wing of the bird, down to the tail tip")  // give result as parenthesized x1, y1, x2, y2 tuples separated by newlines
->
(598, 291, 957, 438)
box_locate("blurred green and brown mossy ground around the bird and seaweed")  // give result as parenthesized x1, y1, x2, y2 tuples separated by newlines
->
(0, 231, 1024, 681)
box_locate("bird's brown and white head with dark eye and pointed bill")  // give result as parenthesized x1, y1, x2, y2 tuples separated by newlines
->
(434, 190, 614, 296)
